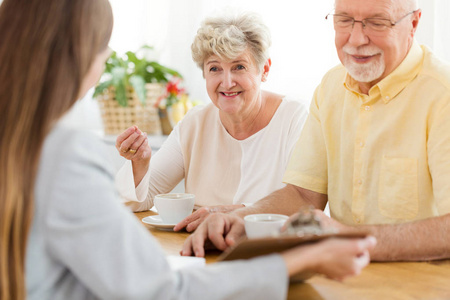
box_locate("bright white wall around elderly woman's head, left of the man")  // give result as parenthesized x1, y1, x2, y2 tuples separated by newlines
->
(106, 0, 338, 107)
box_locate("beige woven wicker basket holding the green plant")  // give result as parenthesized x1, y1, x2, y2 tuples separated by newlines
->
(97, 83, 165, 135)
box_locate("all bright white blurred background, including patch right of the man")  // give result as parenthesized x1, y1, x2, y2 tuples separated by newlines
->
(17, 0, 450, 130)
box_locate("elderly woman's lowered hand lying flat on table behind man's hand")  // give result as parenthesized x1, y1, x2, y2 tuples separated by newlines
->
(173, 204, 244, 232)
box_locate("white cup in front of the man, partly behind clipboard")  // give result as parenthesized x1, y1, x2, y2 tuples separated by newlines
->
(244, 214, 289, 239)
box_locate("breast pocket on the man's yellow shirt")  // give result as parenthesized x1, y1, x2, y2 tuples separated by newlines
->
(378, 157, 419, 220)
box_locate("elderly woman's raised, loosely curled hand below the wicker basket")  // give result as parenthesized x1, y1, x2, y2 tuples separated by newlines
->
(116, 126, 152, 186)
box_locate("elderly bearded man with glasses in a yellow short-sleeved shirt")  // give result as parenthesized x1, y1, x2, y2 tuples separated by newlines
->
(182, 0, 450, 260)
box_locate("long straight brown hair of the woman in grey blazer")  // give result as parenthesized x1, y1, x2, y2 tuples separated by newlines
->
(0, 0, 112, 300)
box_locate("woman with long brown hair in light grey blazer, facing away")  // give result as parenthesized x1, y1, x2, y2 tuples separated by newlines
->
(0, 0, 373, 300)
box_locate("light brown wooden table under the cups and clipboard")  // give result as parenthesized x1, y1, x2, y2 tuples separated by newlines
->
(135, 211, 450, 300)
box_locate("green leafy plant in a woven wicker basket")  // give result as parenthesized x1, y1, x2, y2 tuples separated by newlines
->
(94, 46, 182, 134)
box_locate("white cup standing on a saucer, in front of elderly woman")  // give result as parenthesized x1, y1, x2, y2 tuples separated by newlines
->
(154, 193, 195, 224)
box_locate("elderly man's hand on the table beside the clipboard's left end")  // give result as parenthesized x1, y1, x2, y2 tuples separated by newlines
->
(180, 213, 245, 257)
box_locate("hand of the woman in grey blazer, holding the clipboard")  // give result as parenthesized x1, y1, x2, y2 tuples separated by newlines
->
(281, 236, 376, 281)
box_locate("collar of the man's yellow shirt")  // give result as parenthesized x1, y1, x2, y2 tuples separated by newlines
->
(344, 40, 424, 103)
